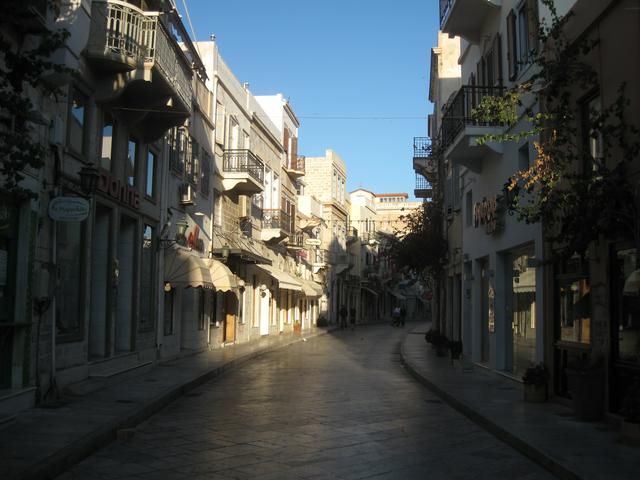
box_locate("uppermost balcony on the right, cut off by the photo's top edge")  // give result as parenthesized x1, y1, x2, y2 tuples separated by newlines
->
(440, 0, 502, 43)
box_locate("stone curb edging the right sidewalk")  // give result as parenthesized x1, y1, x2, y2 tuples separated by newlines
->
(400, 341, 583, 480)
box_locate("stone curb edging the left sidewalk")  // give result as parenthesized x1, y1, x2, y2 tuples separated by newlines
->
(13, 329, 332, 480)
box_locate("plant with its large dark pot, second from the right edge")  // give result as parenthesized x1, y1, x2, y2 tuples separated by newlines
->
(565, 354, 605, 422)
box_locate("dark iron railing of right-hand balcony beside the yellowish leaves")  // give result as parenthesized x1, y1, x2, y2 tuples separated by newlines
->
(442, 85, 504, 149)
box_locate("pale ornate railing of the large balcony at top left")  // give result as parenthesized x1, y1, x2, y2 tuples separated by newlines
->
(88, 0, 192, 109)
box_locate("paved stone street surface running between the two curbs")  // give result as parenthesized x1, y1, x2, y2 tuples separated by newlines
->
(58, 324, 552, 480)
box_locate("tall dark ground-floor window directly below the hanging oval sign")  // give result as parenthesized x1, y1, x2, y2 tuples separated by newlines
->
(55, 222, 85, 340)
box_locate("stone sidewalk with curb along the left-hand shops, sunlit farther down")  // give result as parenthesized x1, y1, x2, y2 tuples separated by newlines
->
(0, 329, 326, 480)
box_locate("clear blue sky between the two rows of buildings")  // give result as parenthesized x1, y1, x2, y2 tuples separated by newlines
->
(176, 0, 438, 197)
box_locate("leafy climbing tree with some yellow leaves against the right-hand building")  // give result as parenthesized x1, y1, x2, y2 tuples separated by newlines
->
(474, 0, 640, 258)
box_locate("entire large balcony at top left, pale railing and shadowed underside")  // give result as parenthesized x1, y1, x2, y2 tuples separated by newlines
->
(84, 0, 193, 141)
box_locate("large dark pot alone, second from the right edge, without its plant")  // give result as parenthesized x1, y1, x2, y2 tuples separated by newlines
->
(566, 369, 604, 422)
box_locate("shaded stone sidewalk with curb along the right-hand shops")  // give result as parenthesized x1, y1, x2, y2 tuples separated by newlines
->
(401, 323, 640, 480)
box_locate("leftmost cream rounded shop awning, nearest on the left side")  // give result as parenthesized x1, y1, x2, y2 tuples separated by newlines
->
(164, 246, 213, 288)
